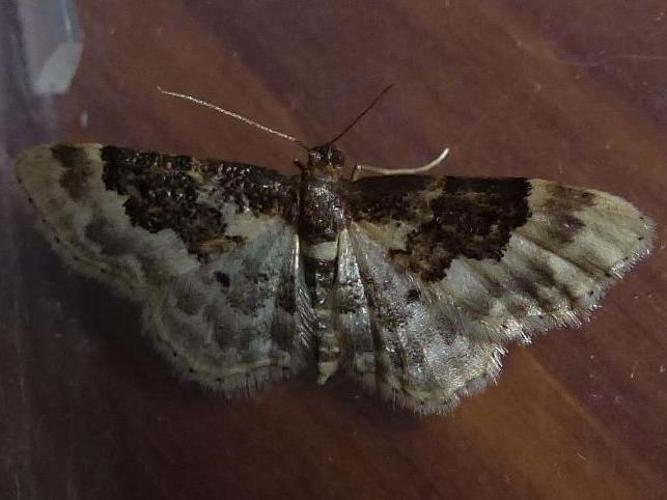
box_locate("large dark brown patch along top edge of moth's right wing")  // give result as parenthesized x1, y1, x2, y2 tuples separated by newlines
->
(349, 176, 530, 281)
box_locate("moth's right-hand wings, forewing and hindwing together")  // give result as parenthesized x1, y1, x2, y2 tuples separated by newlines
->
(345, 176, 654, 411)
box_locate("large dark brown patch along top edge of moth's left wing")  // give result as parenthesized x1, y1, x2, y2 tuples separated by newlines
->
(100, 146, 294, 261)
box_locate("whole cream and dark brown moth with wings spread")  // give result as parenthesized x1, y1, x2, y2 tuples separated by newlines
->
(16, 87, 655, 414)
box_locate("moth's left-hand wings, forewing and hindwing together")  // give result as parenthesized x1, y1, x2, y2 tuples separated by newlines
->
(17, 144, 310, 393)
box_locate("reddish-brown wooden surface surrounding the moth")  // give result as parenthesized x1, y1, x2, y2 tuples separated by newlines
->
(0, 0, 667, 500)
